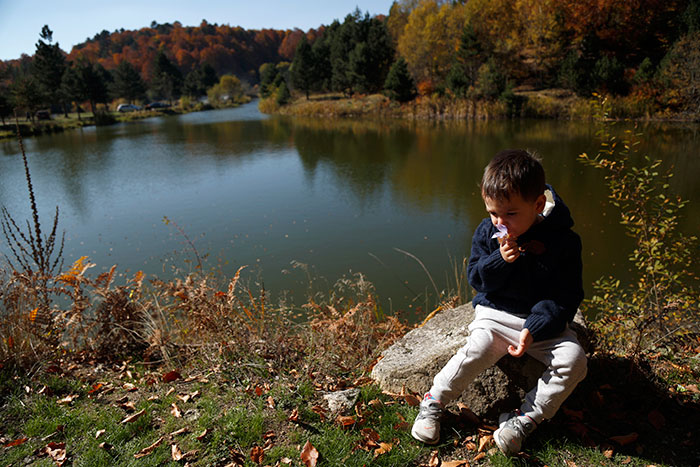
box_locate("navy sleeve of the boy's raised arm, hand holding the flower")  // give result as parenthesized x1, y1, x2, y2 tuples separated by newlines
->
(467, 219, 513, 293)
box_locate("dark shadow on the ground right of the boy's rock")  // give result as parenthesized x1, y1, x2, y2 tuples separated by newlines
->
(430, 356, 700, 467)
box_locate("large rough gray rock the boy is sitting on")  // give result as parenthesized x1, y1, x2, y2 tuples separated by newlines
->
(372, 304, 590, 418)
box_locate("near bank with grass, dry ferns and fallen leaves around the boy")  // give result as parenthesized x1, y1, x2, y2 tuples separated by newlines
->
(0, 259, 700, 467)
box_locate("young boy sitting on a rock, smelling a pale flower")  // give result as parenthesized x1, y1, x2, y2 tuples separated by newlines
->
(411, 150, 587, 456)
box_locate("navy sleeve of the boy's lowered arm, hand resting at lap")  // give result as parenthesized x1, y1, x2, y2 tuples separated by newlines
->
(523, 233, 583, 342)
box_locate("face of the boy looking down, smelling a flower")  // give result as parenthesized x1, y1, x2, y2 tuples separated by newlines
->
(484, 194, 546, 238)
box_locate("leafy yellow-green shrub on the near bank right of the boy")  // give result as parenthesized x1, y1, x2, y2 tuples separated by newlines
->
(579, 98, 700, 358)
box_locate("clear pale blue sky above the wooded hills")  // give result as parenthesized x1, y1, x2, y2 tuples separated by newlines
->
(0, 0, 392, 60)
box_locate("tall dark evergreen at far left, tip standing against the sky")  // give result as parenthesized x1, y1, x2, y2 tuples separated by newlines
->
(33, 25, 66, 114)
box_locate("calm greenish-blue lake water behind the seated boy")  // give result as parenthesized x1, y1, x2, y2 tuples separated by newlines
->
(0, 102, 700, 315)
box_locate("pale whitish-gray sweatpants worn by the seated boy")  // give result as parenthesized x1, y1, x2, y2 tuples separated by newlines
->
(430, 305, 588, 423)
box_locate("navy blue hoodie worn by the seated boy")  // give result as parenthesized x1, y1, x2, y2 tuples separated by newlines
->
(467, 185, 583, 341)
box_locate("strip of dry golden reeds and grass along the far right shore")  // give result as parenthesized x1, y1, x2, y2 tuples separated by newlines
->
(259, 89, 698, 121)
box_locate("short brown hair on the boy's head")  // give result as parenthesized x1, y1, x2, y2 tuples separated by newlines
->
(481, 149, 545, 201)
